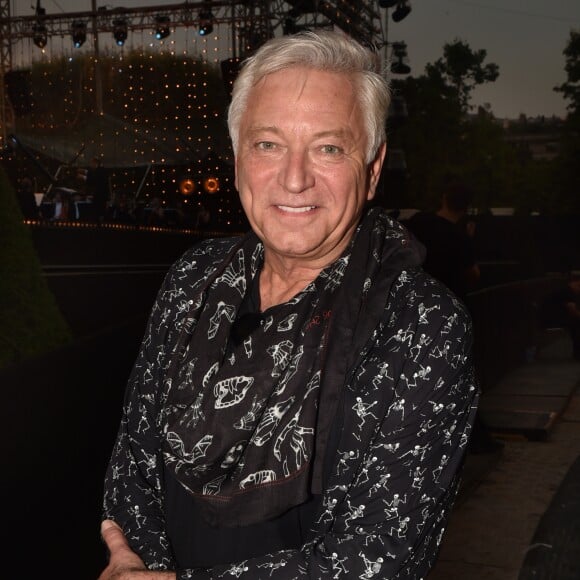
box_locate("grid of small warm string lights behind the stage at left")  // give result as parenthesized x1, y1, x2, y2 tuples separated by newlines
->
(8, 18, 246, 229)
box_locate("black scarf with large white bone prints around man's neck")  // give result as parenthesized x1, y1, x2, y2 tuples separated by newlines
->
(163, 210, 419, 526)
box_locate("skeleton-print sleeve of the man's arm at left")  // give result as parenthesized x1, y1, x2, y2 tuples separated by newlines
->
(103, 238, 242, 570)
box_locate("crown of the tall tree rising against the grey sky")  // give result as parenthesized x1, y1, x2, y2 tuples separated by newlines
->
(425, 39, 499, 112)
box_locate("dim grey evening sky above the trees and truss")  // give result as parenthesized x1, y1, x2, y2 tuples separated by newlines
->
(11, 0, 580, 119)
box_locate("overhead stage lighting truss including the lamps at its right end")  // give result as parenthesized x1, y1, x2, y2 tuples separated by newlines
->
(9, 0, 388, 63)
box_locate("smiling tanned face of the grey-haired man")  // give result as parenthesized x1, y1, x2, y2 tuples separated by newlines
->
(236, 67, 384, 267)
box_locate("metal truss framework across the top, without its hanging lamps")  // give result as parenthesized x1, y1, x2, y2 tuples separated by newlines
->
(0, 0, 384, 60)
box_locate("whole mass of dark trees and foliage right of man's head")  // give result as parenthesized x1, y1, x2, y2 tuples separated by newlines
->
(386, 38, 580, 214)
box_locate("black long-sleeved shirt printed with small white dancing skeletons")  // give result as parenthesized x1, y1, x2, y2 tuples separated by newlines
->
(104, 210, 478, 580)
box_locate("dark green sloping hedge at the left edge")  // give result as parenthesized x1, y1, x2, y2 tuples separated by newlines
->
(0, 167, 71, 368)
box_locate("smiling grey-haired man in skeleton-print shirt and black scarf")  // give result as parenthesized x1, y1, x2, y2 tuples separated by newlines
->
(100, 32, 478, 580)
